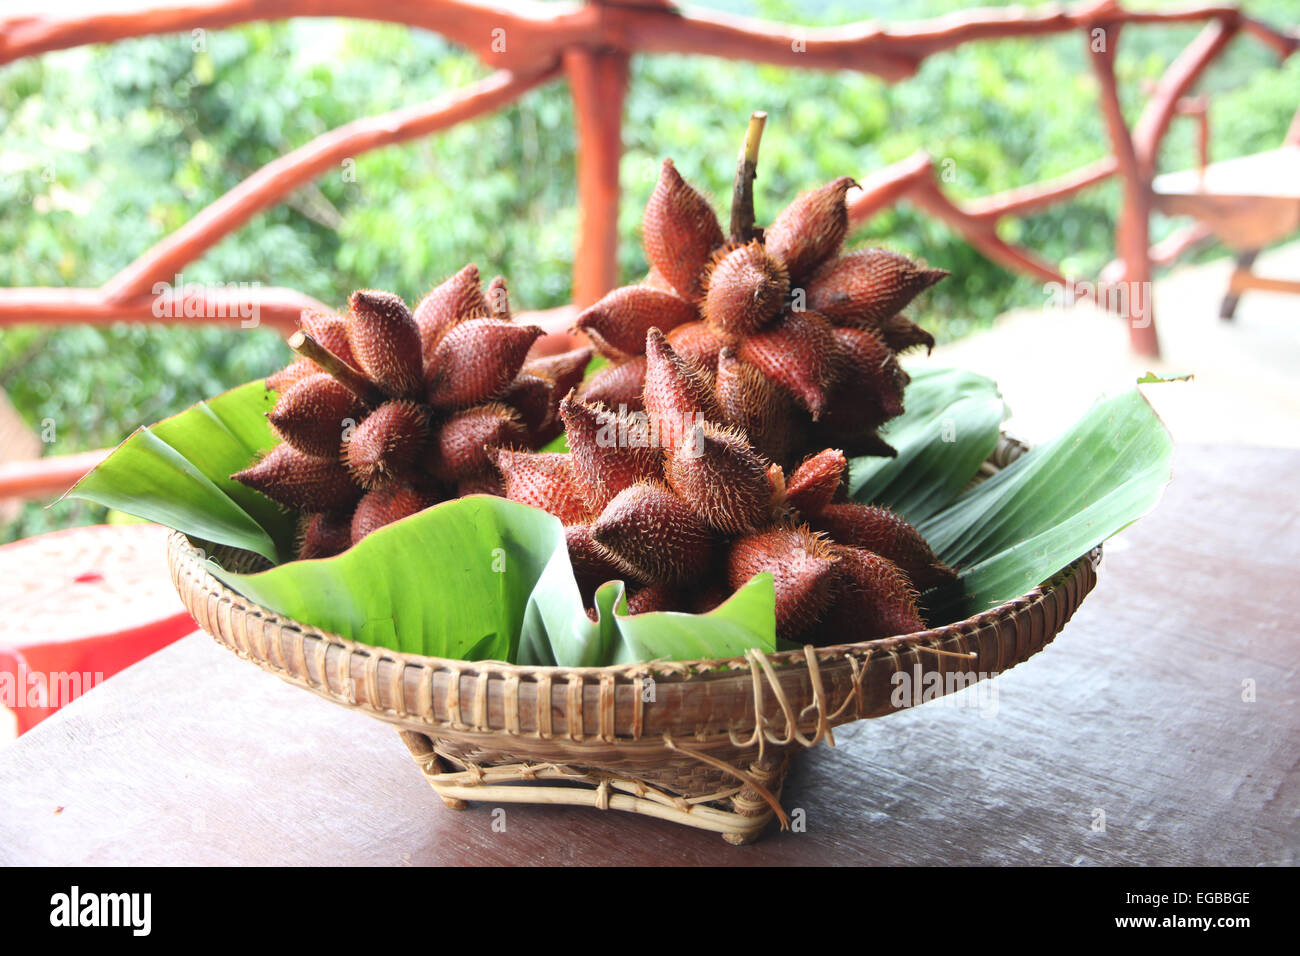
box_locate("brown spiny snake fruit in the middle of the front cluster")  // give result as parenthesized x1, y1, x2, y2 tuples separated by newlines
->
(666, 423, 772, 535)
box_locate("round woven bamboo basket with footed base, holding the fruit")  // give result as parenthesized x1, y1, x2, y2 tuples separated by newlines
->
(168, 437, 1101, 844)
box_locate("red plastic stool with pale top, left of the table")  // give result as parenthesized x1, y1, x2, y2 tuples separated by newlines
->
(0, 524, 198, 734)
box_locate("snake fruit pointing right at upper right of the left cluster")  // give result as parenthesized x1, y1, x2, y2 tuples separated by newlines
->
(428, 319, 542, 411)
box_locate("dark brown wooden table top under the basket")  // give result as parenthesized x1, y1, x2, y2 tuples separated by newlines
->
(0, 446, 1300, 866)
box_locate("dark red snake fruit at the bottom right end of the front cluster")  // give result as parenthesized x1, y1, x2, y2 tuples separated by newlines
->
(824, 545, 926, 644)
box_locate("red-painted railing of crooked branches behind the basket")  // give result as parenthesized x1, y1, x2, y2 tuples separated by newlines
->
(0, 0, 1300, 497)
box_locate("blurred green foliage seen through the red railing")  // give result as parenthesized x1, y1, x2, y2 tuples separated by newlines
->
(0, 0, 1300, 540)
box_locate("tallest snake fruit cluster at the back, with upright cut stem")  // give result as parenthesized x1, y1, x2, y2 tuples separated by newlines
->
(577, 160, 948, 466)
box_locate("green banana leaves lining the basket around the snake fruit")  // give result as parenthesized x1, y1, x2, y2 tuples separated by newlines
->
(61, 368, 1171, 666)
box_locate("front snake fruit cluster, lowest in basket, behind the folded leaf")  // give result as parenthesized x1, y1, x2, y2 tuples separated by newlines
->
(494, 328, 953, 640)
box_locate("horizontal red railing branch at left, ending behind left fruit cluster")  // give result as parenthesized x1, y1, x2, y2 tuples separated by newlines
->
(0, 284, 332, 333)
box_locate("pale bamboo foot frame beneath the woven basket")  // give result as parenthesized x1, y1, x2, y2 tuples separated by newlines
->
(399, 730, 790, 845)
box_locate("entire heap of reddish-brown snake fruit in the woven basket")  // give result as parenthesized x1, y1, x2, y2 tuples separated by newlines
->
(233, 117, 954, 643)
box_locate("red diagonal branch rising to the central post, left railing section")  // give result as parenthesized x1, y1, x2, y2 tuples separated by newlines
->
(104, 68, 556, 302)
